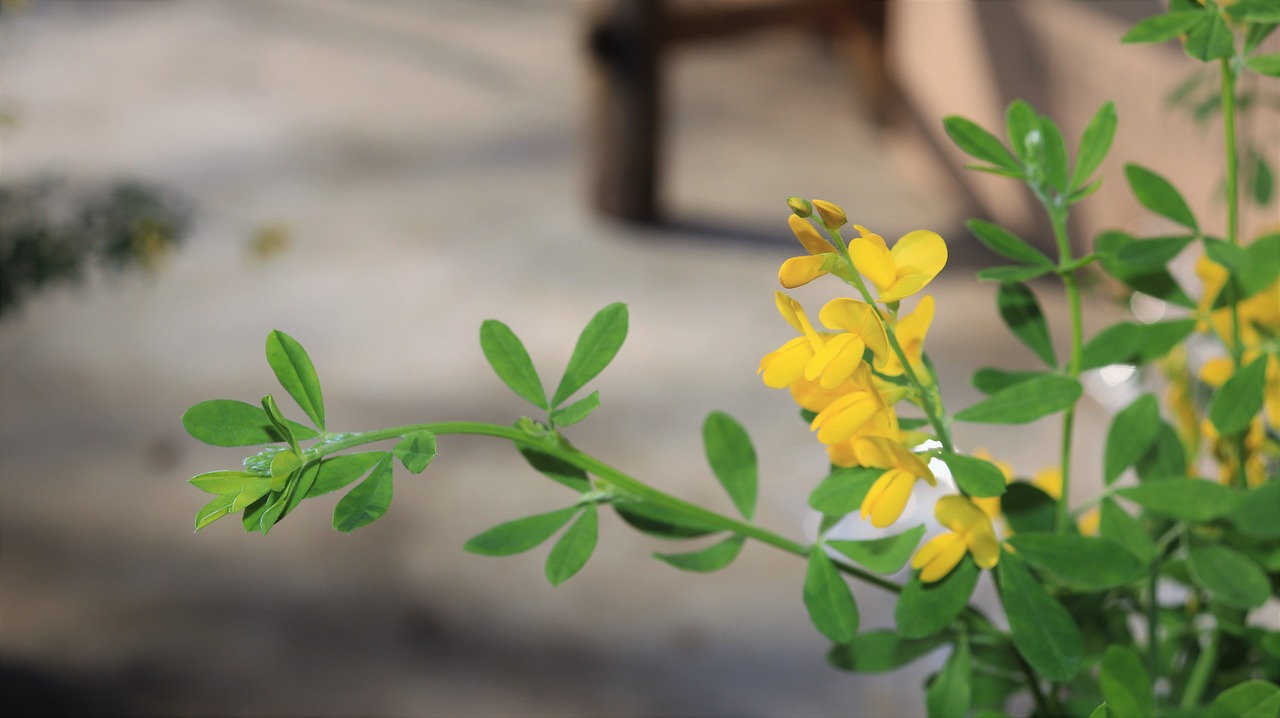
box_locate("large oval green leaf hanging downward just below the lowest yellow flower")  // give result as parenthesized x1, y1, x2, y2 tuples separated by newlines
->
(997, 553, 1084, 681)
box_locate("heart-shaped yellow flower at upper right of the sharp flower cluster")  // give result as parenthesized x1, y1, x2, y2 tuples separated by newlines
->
(849, 224, 947, 302)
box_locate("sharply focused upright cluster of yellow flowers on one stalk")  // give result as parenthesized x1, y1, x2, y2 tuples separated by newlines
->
(759, 197, 1000, 582)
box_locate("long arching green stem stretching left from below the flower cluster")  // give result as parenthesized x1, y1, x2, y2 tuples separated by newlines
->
(314, 421, 902, 594)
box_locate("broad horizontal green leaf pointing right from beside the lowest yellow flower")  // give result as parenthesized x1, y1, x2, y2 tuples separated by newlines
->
(1009, 534, 1147, 593)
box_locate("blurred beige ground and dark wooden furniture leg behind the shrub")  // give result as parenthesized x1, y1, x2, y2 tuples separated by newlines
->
(0, 0, 1277, 717)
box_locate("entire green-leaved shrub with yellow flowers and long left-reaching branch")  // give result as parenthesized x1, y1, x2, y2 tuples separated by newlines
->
(183, 0, 1280, 718)
